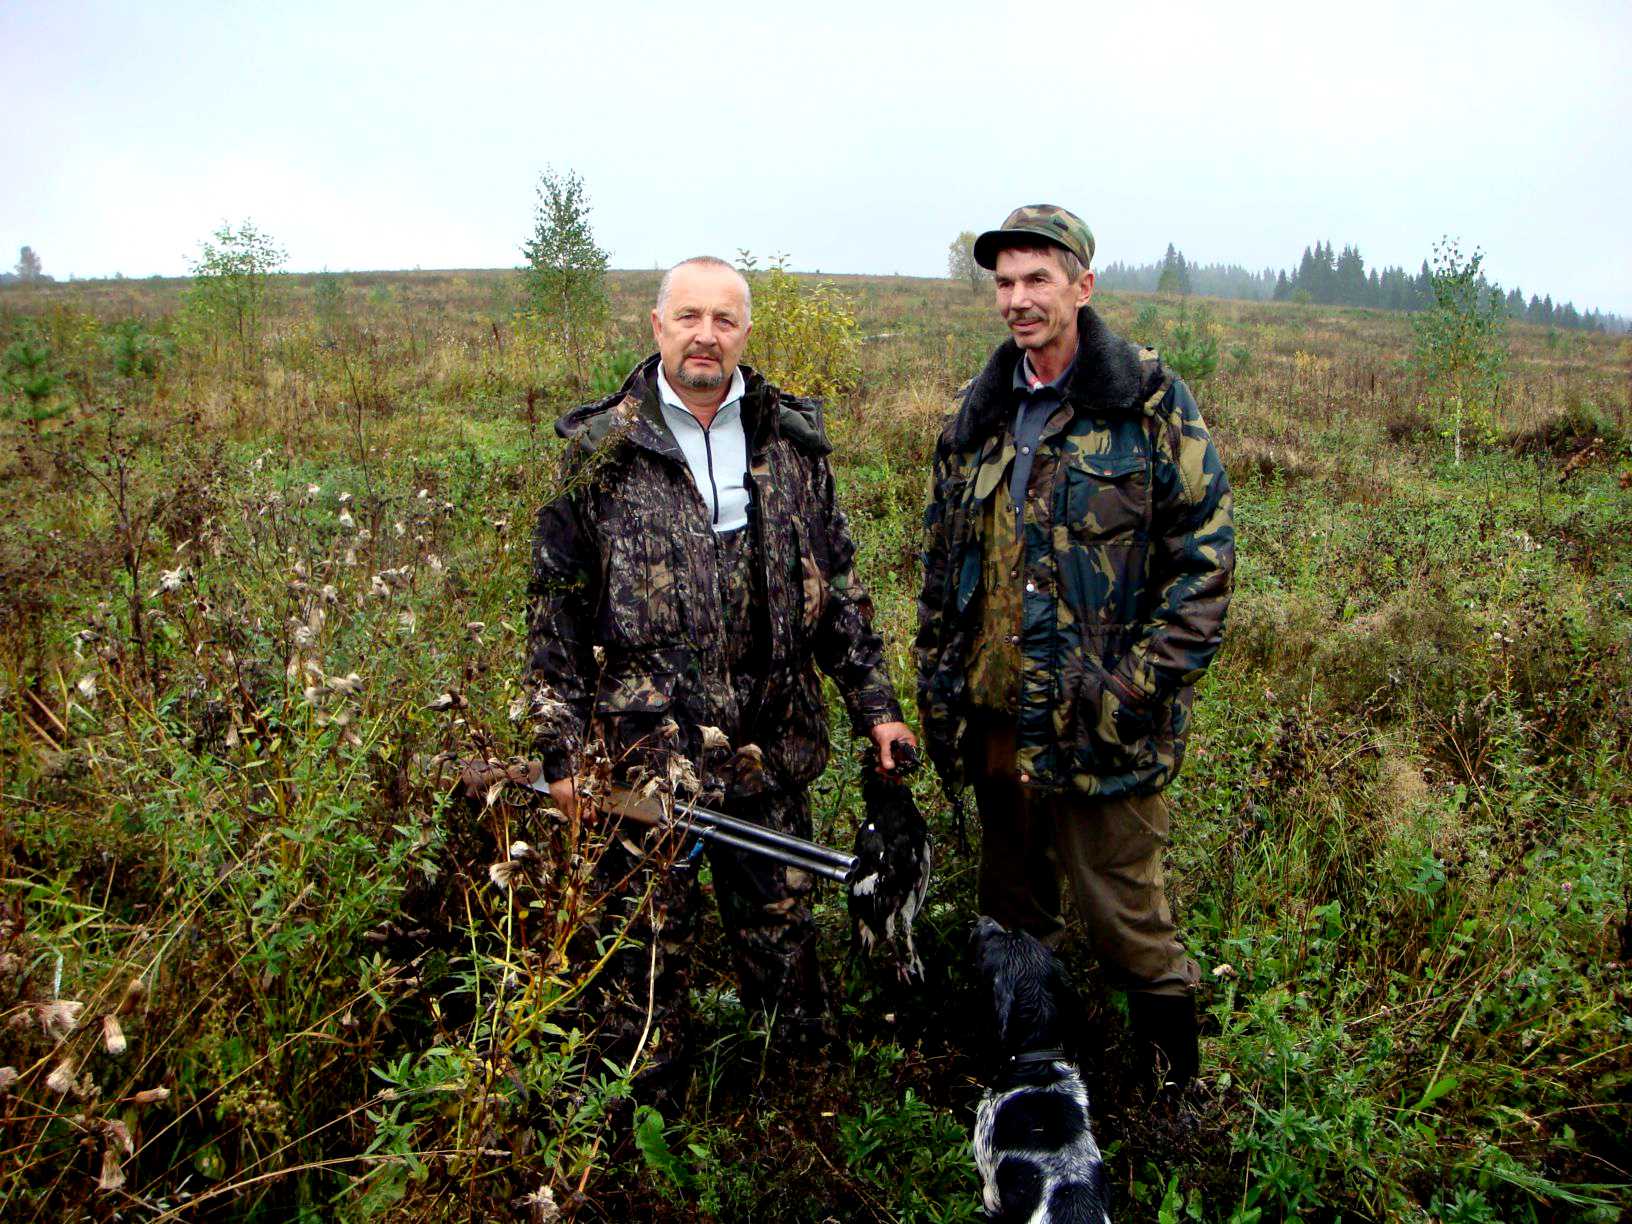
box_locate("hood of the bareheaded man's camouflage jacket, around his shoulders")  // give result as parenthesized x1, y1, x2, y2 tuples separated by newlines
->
(555, 353, 832, 462)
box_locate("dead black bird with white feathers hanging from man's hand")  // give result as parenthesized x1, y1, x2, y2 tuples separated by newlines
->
(850, 741, 930, 982)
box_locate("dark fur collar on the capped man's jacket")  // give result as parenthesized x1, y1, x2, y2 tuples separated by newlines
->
(947, 305, 1167, 450)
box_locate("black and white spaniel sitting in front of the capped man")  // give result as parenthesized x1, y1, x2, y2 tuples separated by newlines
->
(973, 917, 1110, 1224)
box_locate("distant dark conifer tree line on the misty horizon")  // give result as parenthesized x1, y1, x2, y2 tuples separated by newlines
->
(1098, 242, 1632, 331)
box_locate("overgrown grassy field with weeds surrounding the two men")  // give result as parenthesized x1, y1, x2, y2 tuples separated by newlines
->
(0, 271, 1632, 1224)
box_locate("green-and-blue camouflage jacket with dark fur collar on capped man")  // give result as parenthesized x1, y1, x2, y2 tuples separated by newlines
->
(914, 307, 1235, 795)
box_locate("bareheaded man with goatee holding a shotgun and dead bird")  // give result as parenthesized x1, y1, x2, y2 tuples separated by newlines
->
(529, 256, 916, 1064)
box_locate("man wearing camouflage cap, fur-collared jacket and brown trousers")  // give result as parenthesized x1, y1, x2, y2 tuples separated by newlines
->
(916, 204, 1235, 1089)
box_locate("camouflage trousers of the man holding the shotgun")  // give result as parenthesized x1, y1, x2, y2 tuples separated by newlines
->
(584, 792, 827, 1082)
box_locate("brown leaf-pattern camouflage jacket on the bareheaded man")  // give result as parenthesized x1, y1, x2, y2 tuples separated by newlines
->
(527, 354, 901, 788)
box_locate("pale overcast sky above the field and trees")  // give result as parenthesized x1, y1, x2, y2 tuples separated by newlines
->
(0, 0, 1632, 313)
